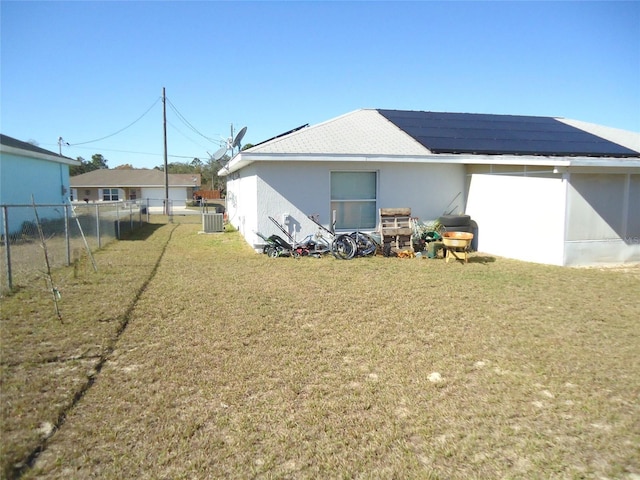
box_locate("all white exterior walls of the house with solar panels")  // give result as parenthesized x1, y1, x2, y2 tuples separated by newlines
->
(227, 161, 640, 265)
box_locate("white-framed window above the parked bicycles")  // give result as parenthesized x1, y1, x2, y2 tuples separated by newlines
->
(331, 172, 377, 230)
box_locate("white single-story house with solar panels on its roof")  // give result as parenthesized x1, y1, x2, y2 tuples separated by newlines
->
(219, 109, 640, 265)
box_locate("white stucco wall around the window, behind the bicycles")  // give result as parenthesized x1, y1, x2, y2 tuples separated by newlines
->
(227, 161, 465, 251)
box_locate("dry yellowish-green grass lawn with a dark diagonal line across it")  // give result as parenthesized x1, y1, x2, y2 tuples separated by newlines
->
(0, 219, 640, 479)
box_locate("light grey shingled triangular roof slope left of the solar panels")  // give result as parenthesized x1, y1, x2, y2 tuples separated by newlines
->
(248, 109, 431, 156)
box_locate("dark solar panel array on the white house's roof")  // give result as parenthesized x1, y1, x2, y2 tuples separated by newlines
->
(378, 110, 638, 157)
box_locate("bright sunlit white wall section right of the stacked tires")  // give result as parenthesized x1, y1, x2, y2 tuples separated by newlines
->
(466, 174, 566, 265)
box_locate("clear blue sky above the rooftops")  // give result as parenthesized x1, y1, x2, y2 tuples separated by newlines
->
(0, 0, 640, 168)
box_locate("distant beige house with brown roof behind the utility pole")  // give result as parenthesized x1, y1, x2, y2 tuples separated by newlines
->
(71, 169, 201, 208)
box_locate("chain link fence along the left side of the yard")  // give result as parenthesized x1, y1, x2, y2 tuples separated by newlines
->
(0, 200, 151, 294)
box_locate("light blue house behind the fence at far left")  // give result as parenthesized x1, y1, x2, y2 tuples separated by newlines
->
(0, 135, 80, 234)
